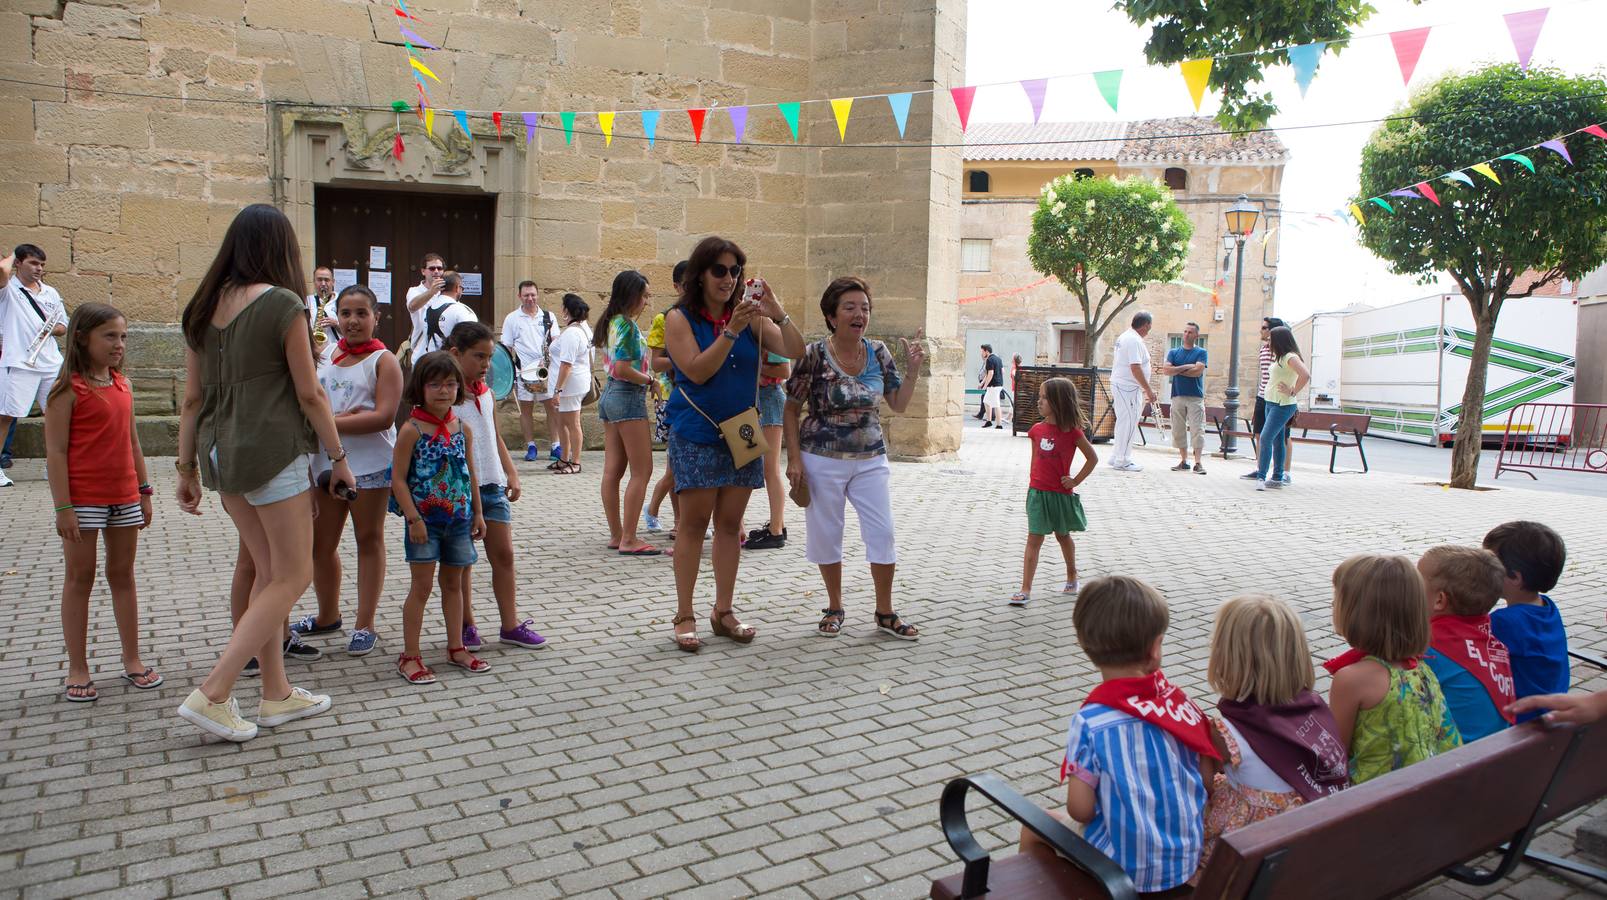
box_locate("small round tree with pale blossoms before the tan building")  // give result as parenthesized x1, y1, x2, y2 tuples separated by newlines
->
(1027, 175, 1194, 365)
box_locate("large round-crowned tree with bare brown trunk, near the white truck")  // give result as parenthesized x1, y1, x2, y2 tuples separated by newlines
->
(1358, 64, 1607, 487)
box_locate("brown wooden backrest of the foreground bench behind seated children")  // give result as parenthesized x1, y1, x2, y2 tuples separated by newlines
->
(1194, 722, 1607, 900)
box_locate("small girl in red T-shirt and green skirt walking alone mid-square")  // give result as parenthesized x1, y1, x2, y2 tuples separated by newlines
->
(1009, 378, 1099, 606)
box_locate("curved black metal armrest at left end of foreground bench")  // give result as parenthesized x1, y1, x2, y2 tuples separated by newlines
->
(938, 775, 1138, 900)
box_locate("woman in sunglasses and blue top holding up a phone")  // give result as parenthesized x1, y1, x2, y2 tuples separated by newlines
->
(664, 236, 804, 653)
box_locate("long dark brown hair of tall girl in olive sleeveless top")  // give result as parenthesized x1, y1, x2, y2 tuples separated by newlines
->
(183, 203, 306, 351)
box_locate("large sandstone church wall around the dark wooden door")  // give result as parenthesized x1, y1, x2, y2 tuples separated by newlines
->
(0, 0, 966, 456)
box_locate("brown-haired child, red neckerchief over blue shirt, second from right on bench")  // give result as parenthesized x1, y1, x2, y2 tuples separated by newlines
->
(1417, 543, 1517, 744)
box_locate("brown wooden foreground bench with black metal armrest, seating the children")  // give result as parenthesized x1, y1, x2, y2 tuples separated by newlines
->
(930, 722, 1607, 900)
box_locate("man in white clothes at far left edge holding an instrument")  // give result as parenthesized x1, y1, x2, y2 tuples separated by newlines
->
(0, 244, 67, 487)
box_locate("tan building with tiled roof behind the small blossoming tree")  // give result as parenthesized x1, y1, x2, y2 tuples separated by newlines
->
(959, 117, 1287, 408)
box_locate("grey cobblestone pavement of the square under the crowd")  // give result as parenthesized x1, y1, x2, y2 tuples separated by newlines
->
(0, 419, 1607, 900)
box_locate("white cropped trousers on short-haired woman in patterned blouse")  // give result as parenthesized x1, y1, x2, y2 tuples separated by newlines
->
(800, 453, 898, 566)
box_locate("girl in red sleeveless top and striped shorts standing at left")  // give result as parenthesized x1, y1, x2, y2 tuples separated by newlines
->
(45, 304, 162, 702)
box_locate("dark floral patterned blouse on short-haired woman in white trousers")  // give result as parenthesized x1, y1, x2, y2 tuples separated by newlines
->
(787, 338, 903, 460)
